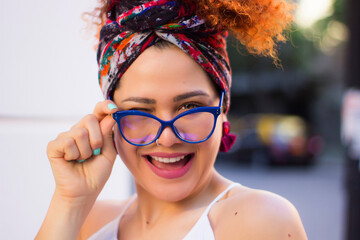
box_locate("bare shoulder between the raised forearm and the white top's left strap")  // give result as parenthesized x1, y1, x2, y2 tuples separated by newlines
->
(79, 200, 127, 239)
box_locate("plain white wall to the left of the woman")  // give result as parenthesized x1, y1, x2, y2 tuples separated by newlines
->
(0, 0, 130, 239)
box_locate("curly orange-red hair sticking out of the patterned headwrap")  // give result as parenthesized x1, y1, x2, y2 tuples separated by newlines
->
(85, 0, 295, 65)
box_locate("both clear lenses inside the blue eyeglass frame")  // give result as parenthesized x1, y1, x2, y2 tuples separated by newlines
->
(120, 112, 214, 144)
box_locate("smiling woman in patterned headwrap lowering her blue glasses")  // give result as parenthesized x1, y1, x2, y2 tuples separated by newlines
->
(37, 0, 307, 240)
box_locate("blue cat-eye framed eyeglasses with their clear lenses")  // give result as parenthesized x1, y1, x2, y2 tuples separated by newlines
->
(112, 91, 224, 146)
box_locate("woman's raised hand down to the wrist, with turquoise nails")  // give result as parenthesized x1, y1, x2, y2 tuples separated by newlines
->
(47, 100, 117, 202)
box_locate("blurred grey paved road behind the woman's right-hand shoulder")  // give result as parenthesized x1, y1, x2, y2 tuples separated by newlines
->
(216, 153, 345, 240)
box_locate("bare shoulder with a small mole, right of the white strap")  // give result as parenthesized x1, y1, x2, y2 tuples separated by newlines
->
(214, 186, 307, 240)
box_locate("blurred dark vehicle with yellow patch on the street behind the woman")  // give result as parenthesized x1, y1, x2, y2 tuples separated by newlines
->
(220, 114, 323, 165)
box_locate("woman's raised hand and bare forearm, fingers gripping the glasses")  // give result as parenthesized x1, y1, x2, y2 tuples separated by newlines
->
(35, 100, 117, 240)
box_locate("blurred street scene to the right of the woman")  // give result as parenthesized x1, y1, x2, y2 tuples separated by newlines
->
(216, 0, 360, 240)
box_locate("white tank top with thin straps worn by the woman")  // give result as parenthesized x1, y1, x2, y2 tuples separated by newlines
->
(88, 183, 239, 240)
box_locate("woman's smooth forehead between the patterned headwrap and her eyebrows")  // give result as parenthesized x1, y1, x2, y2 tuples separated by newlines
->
(114, 45, 216, 98)
